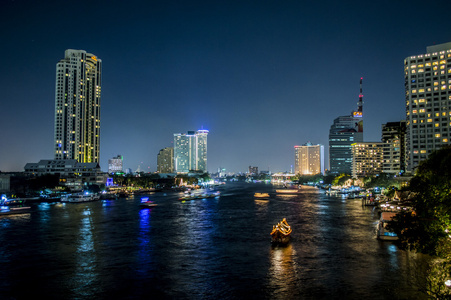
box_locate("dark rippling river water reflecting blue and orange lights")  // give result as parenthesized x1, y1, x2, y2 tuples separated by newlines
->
(0, 183, 430, 299)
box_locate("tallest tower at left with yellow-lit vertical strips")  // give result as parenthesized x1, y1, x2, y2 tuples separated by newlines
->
(54, 49, 102, 163)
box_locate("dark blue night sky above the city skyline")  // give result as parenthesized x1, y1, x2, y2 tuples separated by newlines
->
(0, 0, 451, 172)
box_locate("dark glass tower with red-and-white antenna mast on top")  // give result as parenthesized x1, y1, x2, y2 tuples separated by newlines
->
(329, 78, 363, 174)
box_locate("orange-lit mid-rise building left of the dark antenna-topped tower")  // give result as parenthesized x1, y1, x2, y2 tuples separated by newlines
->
(294, 143, 324, 175)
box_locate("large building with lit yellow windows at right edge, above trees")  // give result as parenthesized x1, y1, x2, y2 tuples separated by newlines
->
(404, 42, 451, 171)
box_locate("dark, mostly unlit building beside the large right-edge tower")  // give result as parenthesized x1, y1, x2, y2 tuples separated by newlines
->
(382, 120, 406, 175)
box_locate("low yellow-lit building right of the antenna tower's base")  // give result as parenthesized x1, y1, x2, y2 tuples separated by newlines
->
(351, 142, 385, 178)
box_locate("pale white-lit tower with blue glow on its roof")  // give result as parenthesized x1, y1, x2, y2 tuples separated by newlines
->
(174, 129, 208, 173)
